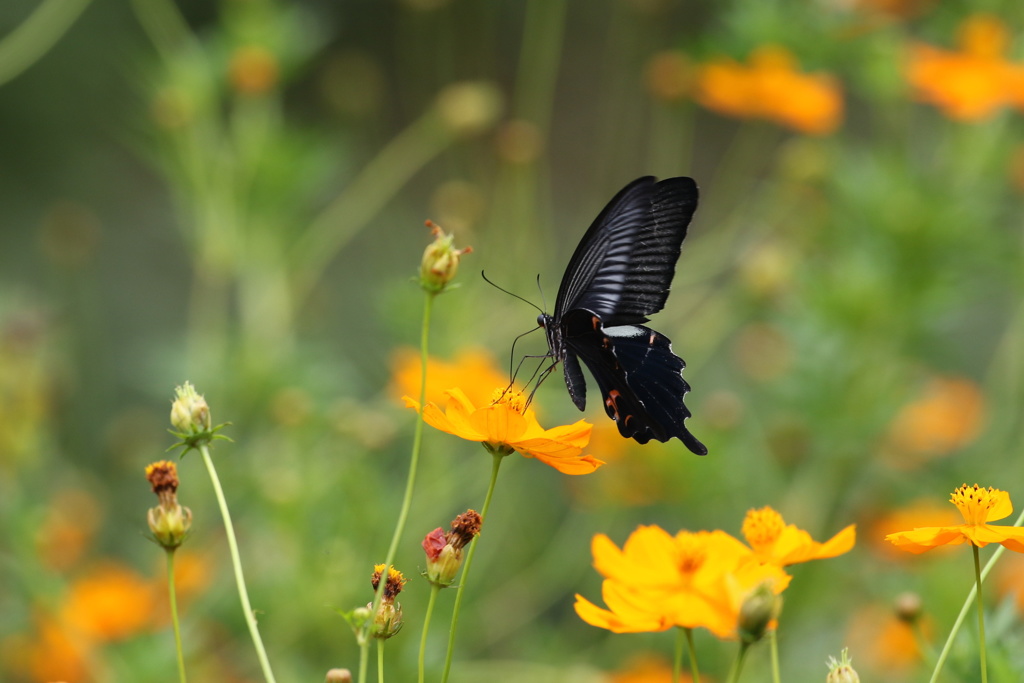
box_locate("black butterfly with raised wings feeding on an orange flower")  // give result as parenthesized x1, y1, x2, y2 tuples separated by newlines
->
(537, 176, 708, 456)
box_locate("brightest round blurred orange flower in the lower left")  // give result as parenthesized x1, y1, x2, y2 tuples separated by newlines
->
(60, 562, 157, 641)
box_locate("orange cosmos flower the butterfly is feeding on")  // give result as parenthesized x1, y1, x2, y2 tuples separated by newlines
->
(403, 388, 604, 474)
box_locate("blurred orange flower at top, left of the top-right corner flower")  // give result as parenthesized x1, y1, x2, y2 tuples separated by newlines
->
(696, 45, 843, 135)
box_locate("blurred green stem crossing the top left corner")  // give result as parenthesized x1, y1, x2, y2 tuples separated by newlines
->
(0, 0, 90, 85)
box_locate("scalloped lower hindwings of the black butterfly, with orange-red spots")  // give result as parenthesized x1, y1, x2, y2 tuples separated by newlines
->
(563, 309, 708, 455)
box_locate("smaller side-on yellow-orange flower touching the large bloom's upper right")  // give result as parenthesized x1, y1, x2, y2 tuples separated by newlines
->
(742, 506, 857, 566)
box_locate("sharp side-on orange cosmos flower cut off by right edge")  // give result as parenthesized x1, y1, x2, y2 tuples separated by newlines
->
(886, 484, 1024, 553)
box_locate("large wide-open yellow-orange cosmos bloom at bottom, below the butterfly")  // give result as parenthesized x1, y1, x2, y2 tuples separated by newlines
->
(575, 526, 790, 638)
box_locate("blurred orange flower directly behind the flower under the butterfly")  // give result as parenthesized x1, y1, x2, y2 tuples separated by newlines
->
(391, 347, 508, 405)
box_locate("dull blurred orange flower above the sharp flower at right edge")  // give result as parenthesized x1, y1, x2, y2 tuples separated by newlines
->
(886, 377, 985, 466)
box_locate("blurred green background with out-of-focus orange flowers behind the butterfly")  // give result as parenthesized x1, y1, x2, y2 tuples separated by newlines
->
(6, 0, 1024, 682)
